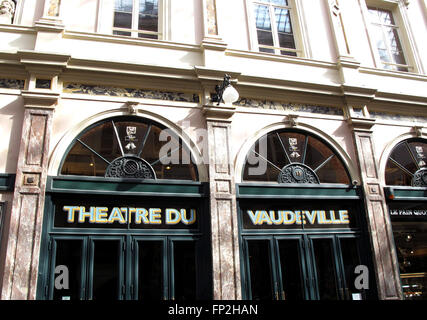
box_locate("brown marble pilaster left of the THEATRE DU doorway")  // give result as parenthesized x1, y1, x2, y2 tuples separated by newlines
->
(1, 91, 59, 300)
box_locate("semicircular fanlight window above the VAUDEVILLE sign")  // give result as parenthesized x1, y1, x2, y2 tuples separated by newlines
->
(243, 130, 350, 184)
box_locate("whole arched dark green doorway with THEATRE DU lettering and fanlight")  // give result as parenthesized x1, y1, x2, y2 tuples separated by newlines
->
(38, 116, 212, 300)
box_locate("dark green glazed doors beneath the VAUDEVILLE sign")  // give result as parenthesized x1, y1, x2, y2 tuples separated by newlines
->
(243, 234, 360, 300)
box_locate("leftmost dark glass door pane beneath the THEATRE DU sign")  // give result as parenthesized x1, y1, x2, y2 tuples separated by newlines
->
(52, 240, 83, 300)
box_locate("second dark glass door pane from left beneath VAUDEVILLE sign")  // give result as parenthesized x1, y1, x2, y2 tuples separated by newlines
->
(279, 239, 304, 300)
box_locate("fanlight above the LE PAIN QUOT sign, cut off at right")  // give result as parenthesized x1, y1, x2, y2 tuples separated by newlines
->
(385, 138, 427, 187)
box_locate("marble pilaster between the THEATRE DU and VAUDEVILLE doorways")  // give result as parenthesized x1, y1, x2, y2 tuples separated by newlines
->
(203, 100, 242, 300)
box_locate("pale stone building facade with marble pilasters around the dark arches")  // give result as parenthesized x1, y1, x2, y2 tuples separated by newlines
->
(0, 0, 427, 300)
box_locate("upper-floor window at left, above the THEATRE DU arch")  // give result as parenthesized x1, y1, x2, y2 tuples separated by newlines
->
(113, 0, 160, 39)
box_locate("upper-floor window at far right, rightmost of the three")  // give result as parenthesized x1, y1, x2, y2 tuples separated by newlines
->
(368, 7, 409, 71)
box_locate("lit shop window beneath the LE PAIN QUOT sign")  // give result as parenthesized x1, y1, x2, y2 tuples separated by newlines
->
(392, 222, 427, 300)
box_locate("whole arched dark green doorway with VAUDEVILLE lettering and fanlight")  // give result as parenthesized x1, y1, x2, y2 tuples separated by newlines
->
(237, 129, 374, 300)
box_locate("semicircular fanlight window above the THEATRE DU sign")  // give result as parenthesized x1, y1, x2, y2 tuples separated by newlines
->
(60, 117, 198, 181)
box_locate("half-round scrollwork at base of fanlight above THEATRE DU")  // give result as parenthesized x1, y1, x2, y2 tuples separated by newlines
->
(105, 156, 156, 179)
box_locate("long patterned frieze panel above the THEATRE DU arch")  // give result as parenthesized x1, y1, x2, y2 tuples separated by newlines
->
(63, 83, 200, 103)
